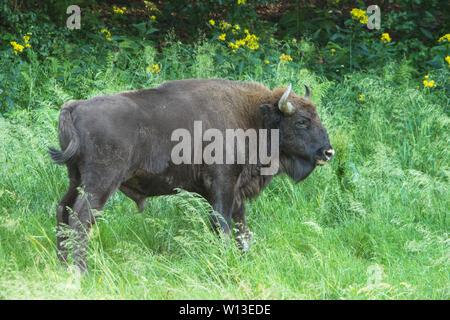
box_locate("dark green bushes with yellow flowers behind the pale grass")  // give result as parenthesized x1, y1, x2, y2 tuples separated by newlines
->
(0, 0, 450, 112)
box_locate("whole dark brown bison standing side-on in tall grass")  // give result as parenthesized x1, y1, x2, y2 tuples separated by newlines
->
(49, 79, 334, 271)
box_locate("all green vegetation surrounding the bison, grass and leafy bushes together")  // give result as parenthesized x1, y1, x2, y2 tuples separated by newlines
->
(0, 0, 450, 299)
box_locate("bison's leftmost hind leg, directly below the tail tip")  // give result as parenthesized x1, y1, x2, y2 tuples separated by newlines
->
(56, 165, 81, 265)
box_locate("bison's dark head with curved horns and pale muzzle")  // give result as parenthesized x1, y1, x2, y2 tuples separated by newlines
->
(261, 85, 334, 182)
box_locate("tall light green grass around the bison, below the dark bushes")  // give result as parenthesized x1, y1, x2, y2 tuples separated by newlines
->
(0, 43, 450, 299)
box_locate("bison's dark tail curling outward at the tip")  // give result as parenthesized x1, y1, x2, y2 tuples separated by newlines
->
(48, 101, 80, 164)
